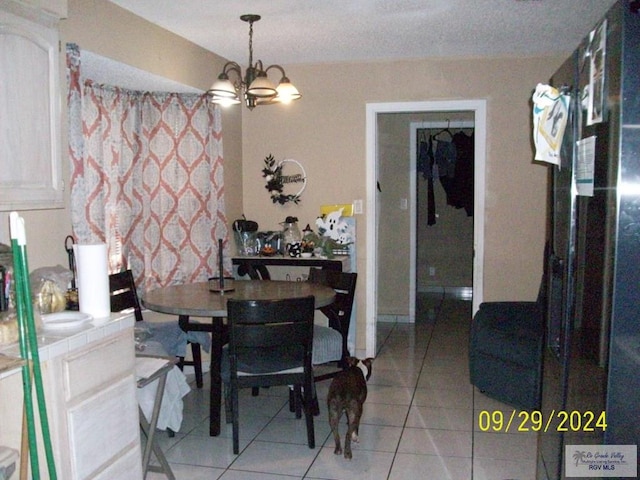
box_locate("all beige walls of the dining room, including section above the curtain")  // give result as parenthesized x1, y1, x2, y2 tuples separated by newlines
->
(0, 0, 573, 349)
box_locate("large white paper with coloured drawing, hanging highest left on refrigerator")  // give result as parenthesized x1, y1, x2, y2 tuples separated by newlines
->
(532, 83, 570, 165)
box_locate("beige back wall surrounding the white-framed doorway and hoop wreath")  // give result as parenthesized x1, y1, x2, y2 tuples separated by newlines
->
(243, 56, 571, 349)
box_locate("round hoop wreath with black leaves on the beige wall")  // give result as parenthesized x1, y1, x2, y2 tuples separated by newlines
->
(262, 154, 307, 205)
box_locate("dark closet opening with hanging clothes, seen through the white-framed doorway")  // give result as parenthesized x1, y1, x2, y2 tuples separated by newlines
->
(410, 116, 475, 300)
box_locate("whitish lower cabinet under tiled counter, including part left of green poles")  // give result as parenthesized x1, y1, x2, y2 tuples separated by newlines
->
(0, 317, 143, 480)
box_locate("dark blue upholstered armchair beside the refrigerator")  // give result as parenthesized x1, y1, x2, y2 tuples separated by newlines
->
(469, 281, 546, 409)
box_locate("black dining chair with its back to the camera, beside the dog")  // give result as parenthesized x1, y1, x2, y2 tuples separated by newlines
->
(221, 296, 315, 455)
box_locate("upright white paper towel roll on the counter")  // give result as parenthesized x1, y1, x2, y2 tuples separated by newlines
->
(73, 243, 111, 318)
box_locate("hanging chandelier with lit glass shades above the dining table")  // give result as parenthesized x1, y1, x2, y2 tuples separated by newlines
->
(207, 14, 302, 110)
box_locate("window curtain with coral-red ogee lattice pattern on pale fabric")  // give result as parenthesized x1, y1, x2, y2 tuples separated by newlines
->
(67, 45, 230, 290)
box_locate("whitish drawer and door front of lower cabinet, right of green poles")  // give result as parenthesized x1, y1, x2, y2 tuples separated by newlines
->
(48, 330, 142, 480)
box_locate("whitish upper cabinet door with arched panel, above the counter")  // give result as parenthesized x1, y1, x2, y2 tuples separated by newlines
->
(0, 5, 63, 210)
